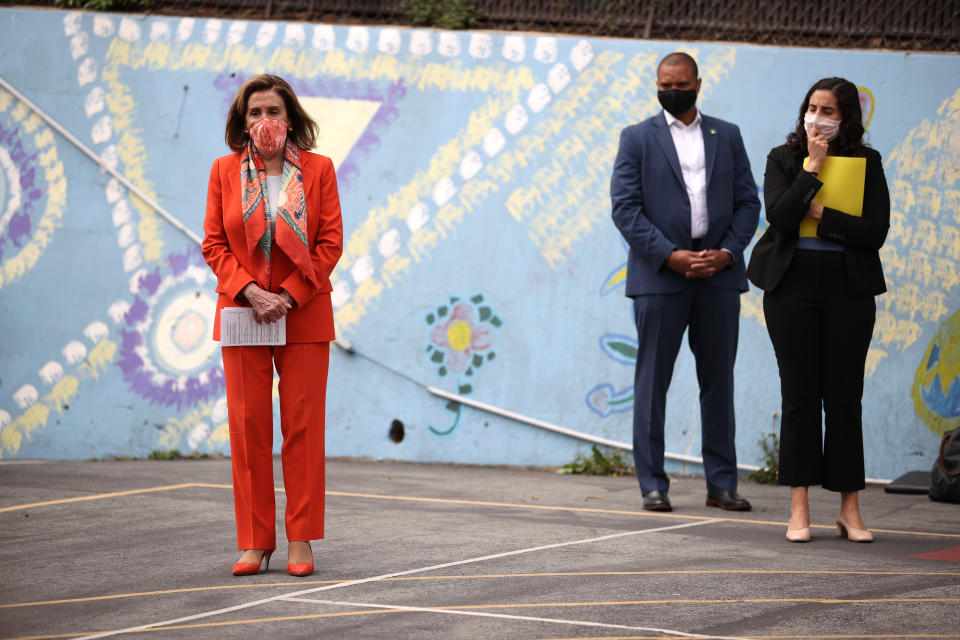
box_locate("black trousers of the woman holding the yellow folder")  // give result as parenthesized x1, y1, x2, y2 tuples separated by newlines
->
(763, 250, 876, 491)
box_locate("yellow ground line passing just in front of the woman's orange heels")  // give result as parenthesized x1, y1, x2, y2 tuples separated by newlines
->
(0, 569, 960, 609)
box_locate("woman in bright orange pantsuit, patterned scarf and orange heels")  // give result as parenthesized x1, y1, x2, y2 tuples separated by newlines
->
(203, 75, 343, 576)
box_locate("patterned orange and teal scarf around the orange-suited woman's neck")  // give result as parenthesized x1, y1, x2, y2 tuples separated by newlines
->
(240, 140, 319, 291)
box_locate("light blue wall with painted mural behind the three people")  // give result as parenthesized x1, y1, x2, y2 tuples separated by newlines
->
(0, 8, 960, 478)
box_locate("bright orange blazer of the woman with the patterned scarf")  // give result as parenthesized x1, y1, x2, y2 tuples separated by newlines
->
(202, 151, 343, 342)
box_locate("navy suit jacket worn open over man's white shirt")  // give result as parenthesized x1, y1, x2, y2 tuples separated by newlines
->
(610, 111, 760, 297)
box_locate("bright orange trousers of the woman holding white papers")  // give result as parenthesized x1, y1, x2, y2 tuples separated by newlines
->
(222, 342, 330, 549)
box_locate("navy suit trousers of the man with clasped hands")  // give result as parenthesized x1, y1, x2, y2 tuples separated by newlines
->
(633, 279, 740, 494)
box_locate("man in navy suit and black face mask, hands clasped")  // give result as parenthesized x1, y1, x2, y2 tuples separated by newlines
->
(610, 53, 760, 511)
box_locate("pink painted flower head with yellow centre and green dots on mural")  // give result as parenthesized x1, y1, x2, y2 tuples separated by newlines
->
(427, 294, 502, 376)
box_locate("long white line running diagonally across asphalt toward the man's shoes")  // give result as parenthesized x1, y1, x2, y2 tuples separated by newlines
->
(74, 520, 721, 640)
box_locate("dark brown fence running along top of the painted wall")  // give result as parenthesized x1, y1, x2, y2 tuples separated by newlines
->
(20, 0, 960, 51)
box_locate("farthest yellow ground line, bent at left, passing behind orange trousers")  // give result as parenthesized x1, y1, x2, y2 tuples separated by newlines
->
(0, 482, 960, 539)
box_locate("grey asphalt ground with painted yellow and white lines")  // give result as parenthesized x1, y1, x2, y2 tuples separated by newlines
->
(0, 460, 960, 640)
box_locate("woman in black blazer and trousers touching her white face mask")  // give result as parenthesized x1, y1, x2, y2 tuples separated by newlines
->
(747, 78, 890, 542)
